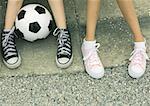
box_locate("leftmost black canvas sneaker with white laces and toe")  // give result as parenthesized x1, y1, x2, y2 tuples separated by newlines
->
(1, 27, 21, 69)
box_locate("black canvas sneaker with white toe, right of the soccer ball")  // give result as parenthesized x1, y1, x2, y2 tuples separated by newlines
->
(53, 28, 73, 68)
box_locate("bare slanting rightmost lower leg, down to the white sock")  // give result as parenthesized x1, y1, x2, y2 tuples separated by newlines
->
(117, 0, 144, 42)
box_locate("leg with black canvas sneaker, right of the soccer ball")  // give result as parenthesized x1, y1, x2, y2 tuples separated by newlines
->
(48, 0, 73, 68)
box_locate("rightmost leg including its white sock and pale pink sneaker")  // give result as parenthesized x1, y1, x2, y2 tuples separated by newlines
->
(117, 0, 148, 78)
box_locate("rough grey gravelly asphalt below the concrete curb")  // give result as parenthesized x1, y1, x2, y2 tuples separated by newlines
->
(0, 63, 150, 106)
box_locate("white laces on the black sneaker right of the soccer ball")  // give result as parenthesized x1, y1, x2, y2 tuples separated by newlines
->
(53, 28, 70, 55)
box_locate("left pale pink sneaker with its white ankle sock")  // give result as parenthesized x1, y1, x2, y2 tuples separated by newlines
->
(81, 39, 104, 79)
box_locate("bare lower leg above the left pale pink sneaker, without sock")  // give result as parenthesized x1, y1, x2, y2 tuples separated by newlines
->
(85, 0, 100, 41)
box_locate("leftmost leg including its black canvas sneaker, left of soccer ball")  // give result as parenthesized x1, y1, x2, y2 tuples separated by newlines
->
(1, 0, 23, 68)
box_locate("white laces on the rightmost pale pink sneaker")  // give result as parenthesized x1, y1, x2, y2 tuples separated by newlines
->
(129, 49, 149, 64)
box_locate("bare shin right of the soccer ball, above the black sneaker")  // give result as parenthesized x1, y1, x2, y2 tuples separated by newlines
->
(48, 0, 66, 29)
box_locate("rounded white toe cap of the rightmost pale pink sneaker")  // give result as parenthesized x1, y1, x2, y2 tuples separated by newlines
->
(128, 66, 145, 78)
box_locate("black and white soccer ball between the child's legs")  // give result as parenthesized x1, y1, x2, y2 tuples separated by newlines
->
(15, 4, 52, 42)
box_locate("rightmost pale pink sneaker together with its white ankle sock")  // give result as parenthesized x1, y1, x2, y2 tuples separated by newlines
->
(128, 42, 149, 78)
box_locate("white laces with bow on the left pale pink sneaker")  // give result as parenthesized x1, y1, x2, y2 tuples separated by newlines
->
(83, 43, 100, 65)
